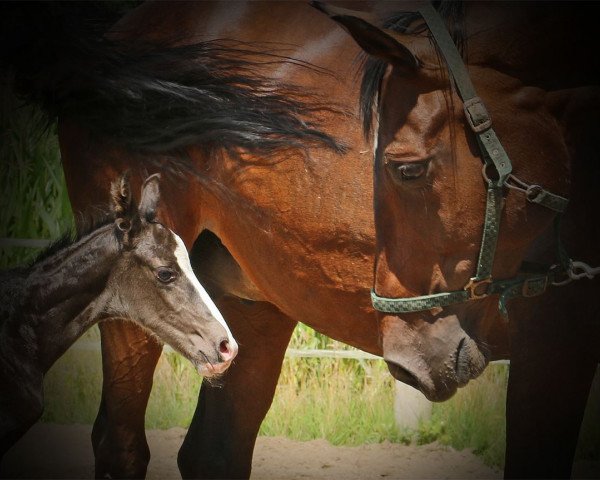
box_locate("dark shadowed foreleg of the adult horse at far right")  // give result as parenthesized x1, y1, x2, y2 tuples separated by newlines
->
(505, 298, 598, 478)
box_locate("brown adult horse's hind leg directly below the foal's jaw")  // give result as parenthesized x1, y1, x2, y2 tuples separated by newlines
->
(92, 321, 162, 478)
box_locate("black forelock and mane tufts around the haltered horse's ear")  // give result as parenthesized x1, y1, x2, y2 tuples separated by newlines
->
(360, 0, 466, 138)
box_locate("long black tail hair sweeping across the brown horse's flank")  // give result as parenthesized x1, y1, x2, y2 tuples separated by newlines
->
(0, 2, 343, 155)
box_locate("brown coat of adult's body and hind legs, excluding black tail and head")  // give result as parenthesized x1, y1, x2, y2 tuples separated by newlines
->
(60, 2, 381, 478)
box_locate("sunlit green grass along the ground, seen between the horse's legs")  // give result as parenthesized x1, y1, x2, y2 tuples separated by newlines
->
(42, 326, 507, 466)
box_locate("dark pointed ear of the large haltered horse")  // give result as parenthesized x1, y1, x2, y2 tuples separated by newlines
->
(311, 1, 419, 74)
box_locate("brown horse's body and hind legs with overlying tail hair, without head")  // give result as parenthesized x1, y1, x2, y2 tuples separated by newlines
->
(48, 2, 381, 478)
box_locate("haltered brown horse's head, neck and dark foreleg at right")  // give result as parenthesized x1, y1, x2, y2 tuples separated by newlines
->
(320, 2, 600, 478)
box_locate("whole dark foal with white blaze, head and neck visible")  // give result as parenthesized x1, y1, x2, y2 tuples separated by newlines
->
(0, 175, 237, 459)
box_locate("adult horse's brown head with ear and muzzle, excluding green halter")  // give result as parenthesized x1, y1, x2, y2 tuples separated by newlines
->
(320, 2, 567, 401)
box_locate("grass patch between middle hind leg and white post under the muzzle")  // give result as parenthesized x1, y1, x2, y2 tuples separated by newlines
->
(260, 358, 401, 445)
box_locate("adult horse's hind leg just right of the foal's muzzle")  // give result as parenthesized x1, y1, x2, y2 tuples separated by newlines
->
(178, 297, 296, 478)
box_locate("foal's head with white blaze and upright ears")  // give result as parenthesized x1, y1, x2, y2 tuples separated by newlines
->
(107, 174, 238, 376)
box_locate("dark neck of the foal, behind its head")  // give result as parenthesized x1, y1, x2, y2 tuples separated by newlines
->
(0, 225, 119, 372)
